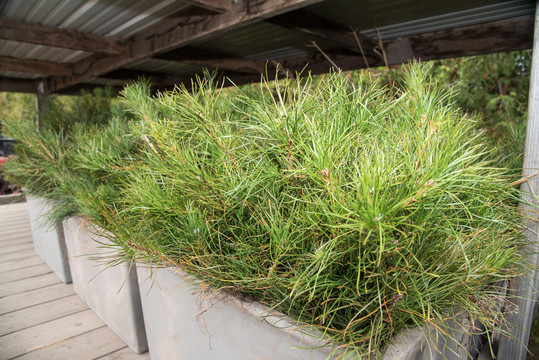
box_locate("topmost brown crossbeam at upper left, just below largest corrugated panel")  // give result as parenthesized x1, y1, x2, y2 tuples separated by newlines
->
(0, 17, 123, 55)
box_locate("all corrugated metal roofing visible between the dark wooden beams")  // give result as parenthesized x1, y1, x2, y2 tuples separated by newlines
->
(0, 0, 536, 93)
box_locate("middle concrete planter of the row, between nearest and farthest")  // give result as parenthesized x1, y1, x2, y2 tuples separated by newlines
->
(64, 217, 148, 353)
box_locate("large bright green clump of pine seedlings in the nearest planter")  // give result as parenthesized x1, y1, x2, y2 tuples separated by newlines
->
(95, 65, 527, 358)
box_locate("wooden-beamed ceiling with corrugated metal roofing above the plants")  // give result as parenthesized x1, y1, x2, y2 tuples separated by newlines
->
(0, 0, 535, 94)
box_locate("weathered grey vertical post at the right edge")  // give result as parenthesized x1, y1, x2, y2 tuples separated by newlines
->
(497, 3, 539, 360)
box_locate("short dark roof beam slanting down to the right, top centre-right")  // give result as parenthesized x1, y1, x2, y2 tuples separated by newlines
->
(267, 9, 376, 56)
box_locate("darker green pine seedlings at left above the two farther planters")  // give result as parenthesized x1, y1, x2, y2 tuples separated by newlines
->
(2, 89, 137, 225)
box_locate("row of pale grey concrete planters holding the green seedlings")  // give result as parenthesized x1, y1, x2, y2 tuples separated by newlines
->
(28, 197, 476, 360)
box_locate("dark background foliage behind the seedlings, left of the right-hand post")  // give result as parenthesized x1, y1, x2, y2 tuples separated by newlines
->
(359, 50, 531, 176)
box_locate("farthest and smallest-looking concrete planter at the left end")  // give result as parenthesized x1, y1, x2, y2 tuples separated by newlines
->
(26, 196, 71, 283)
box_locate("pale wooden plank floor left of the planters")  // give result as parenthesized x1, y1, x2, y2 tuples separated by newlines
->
(0, 203, 150, 360)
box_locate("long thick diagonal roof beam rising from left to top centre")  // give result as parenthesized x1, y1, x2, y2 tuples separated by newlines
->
(48, 0, 322, 91)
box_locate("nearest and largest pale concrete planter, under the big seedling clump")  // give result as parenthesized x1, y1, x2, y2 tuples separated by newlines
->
(137, 265, 478, 360)
